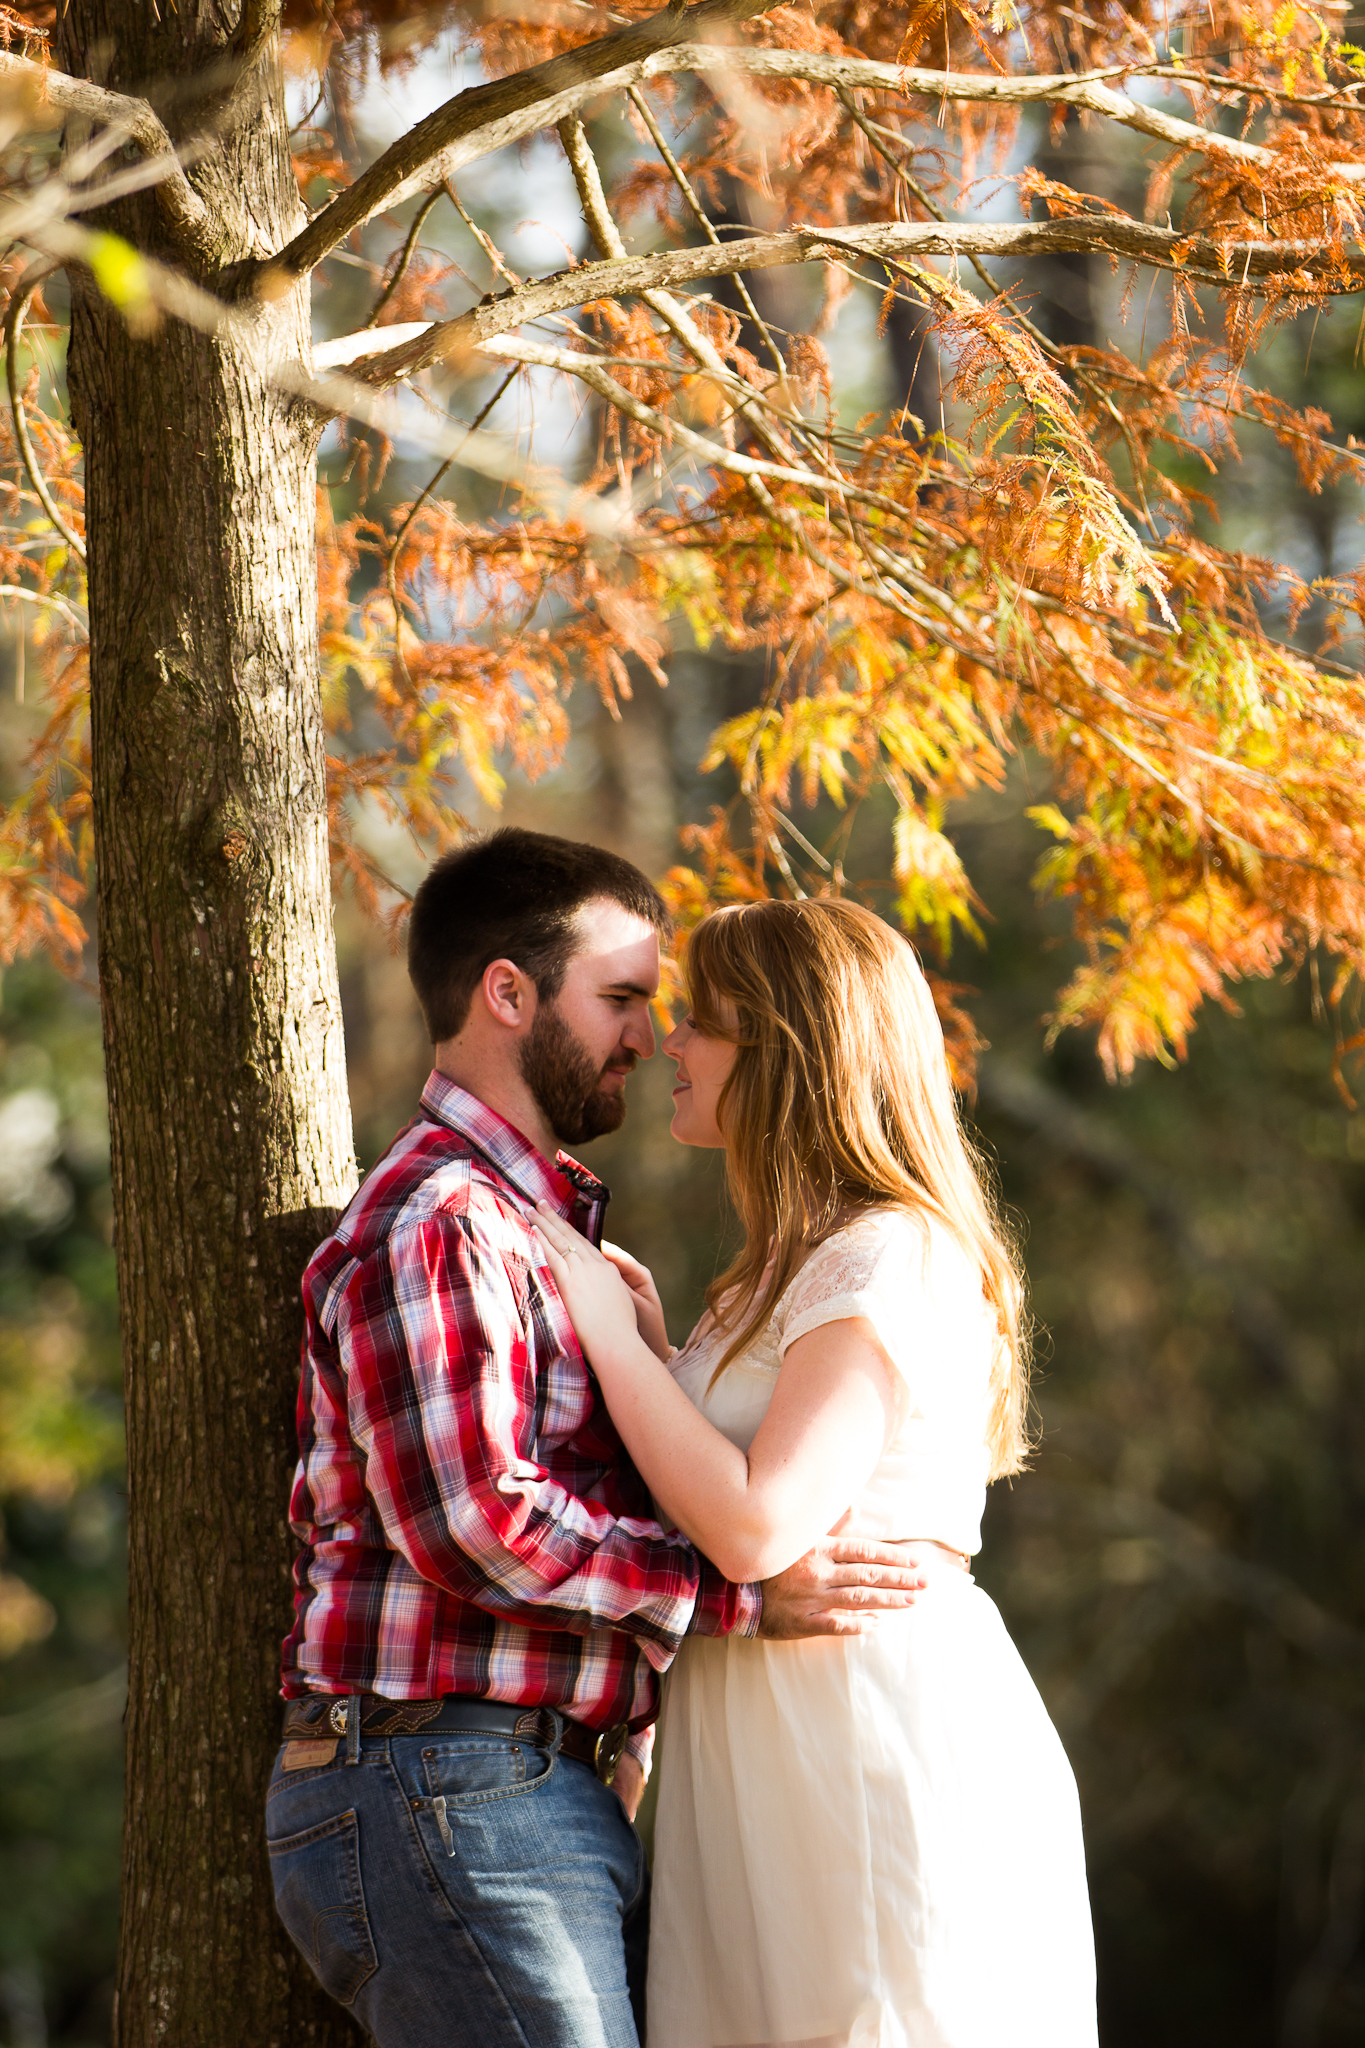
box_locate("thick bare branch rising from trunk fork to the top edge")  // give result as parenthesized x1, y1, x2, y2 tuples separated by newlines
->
(253, 0, 774, 295)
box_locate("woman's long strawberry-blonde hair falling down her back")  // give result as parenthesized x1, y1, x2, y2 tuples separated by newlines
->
(686, 899, 1029, 1479)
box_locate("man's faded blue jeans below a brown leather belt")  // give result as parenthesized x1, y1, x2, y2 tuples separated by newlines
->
(266, 1735, 649, 2048)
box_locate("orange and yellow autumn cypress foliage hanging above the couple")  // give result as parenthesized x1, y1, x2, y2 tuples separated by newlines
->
(0, 0, 1365, 1085)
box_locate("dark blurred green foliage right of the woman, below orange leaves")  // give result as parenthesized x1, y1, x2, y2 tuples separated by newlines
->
(968, 851, 1365, 2048)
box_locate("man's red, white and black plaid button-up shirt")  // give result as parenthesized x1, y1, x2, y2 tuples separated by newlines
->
(282, 1073, 759, 1753)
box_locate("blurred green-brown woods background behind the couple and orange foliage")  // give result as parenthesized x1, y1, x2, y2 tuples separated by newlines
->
(0, 32, 1365, 2048)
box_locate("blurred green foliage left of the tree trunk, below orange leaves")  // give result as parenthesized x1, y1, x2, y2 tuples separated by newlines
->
(0, 963, 125, 2048)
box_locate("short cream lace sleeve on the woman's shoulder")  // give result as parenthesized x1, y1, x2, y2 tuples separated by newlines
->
(780, 1214, 925, 1374)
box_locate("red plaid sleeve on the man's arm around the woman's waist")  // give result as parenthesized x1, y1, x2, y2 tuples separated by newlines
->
(338, 1214, 759, 1671)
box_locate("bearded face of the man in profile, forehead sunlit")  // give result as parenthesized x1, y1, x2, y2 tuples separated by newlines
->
(520, 897, 659, 1145)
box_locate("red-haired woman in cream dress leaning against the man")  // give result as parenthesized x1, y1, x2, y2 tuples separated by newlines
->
(542, 901, 1095, 2048)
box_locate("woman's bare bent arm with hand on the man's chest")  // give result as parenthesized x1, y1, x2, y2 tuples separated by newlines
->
(540, 1206, 900, 1583)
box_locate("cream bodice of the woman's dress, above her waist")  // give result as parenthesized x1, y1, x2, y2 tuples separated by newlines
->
(671, 1208, 999, 1552)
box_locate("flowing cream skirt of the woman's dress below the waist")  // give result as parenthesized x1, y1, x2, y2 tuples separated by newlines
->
(649, 1573, 1097, 2048)
